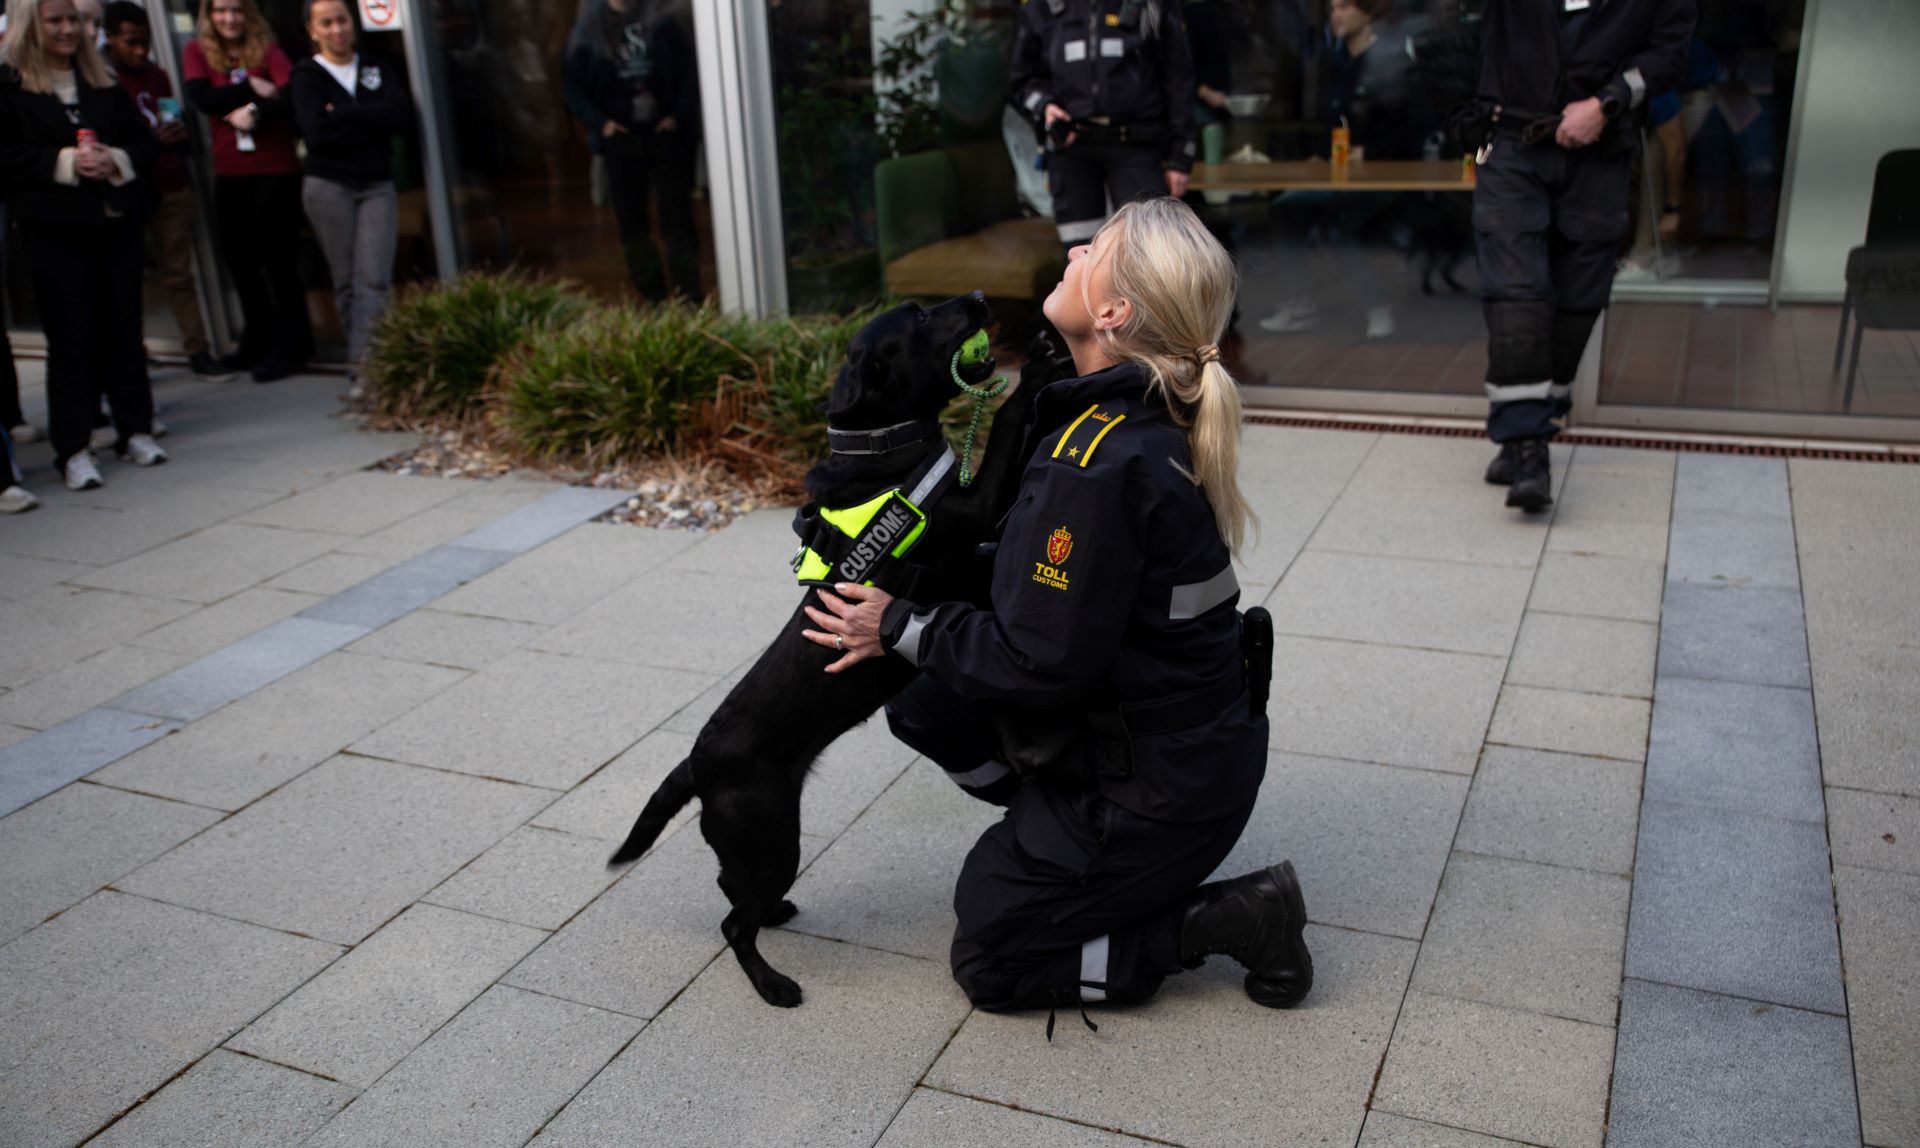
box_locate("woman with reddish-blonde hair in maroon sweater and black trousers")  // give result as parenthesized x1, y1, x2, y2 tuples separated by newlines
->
(180, 0, 313, 382)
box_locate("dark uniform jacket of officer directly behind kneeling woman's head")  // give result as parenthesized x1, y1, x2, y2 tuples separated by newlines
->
(1010, 0, 1194, 171)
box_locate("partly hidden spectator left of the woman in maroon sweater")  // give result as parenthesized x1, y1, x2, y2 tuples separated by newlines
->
(104, 0, 228, 378)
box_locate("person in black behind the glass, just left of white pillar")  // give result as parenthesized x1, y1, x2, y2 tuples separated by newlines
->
(563, 0, 701, 299)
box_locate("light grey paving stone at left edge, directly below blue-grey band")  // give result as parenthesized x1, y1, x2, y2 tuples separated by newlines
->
(0, 785, 221, 945)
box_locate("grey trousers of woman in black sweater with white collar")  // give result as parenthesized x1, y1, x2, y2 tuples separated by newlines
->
(300, 175, 399, 367)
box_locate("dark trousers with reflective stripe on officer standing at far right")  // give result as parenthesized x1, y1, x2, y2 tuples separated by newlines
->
(1473, 136, 1632, 442)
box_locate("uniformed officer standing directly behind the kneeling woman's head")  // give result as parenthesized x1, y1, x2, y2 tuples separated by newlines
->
(1012, 0, 1194, 251)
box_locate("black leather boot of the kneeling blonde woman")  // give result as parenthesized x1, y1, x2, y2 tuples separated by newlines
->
(1181, 862, 1313, 1008)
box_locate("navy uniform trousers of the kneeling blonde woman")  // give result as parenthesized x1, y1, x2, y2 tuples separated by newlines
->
(887, 676, 1254, 1010)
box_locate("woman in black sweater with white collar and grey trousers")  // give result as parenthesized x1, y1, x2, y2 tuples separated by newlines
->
(288, 0, 413, 372)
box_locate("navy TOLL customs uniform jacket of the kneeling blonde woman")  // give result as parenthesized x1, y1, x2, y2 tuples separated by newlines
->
(883, 363, 1267, 820)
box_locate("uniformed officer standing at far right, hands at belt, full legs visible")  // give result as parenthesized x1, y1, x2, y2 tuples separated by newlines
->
(1461, 0, 1693, 511)
